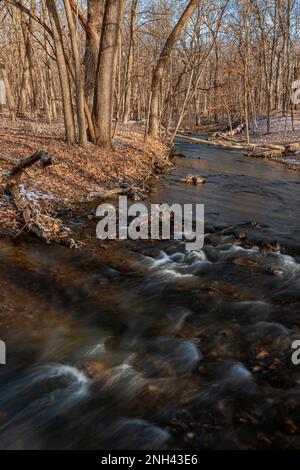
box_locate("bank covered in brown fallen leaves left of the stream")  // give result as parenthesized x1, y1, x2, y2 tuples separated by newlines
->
(0, 119, 171, 242)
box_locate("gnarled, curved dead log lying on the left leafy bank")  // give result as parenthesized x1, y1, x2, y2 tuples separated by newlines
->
(2, 150, 78, 248)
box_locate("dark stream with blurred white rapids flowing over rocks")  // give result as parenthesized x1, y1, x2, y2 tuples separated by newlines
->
(0, 138, 300, 450)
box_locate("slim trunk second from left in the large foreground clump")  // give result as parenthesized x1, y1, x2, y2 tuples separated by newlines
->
(64, 0, 87, 145)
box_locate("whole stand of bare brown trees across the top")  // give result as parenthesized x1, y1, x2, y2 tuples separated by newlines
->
(0, 0, 300, 147)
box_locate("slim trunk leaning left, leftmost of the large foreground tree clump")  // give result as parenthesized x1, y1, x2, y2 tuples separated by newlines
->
(46, 0, 76, 144)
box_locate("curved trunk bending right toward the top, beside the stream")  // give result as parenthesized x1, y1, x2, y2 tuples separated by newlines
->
(148, 0, 201, 139)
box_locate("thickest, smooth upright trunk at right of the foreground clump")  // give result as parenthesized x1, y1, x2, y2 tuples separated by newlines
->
(93, 0, 125, 147)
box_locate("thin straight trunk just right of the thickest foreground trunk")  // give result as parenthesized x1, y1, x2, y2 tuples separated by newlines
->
(123, 0, 138, 124)
